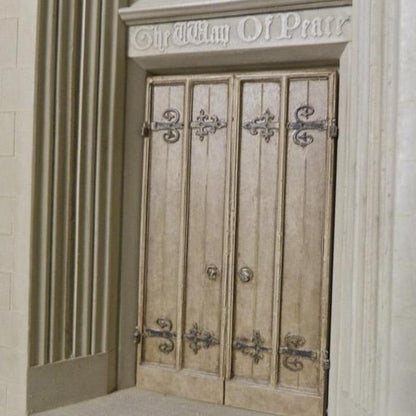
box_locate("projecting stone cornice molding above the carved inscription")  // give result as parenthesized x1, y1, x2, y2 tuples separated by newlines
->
(119, 0, 352, 26)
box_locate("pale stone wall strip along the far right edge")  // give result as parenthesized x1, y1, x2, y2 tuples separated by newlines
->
(389, 0, 416, 416)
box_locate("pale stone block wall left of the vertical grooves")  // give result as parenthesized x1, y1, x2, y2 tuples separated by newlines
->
(0, 0, 37, 416)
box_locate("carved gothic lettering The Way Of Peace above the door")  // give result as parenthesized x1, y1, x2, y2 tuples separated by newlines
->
(132, 9, 351, 53)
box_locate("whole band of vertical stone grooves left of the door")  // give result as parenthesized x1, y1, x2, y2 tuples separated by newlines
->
(30, 0, 124, 366)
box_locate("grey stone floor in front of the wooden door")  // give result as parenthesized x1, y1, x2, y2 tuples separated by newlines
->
(36, 388, 270, 416)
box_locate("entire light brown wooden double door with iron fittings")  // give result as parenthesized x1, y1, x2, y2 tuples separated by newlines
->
(137, 70, 336, 416)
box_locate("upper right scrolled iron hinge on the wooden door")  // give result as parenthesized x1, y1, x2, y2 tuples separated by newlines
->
(287, 105, 330, 147)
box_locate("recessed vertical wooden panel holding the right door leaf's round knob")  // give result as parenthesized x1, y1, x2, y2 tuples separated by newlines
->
(233, 81, 280, 382)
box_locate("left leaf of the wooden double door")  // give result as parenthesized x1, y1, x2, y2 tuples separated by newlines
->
(137, 77, 231, 403)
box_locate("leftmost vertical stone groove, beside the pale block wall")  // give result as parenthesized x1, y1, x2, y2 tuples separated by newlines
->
(30, 0, 58, 365)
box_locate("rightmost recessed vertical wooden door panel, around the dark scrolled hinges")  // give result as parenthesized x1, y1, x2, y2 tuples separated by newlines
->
(280, 80, 329, 393)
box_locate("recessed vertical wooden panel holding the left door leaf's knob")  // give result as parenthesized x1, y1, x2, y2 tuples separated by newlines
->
(184, 83, 228, 374)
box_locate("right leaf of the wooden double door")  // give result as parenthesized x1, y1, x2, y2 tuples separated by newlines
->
(224, 74, 335, 416)
